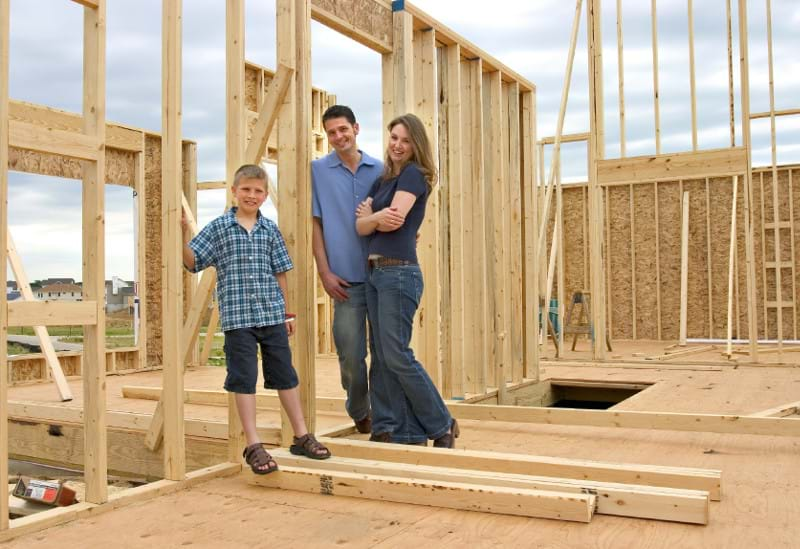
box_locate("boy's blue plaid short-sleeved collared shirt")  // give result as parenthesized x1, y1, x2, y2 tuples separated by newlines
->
(189, 208, 292, 332)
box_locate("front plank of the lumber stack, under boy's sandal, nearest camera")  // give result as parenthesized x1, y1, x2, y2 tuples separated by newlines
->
(246, 467, 596, 522)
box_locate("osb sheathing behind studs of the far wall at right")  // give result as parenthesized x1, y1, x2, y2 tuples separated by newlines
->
(560, 167, 800, 340)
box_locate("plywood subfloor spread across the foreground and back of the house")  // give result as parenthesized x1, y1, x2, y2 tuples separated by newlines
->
(4, 359, 800, 549)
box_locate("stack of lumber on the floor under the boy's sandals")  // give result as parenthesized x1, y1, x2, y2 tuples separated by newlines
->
(247, 438, 721, 524)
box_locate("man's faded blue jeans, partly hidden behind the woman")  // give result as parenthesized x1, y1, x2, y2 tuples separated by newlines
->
(333, 283, 369, 421)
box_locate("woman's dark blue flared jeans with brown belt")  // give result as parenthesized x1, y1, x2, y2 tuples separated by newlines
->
(367, 265, 451, 443)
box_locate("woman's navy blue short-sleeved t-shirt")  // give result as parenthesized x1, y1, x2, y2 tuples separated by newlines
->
(368, 163, 428, 263)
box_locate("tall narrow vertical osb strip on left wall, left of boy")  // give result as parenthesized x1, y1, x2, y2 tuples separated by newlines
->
(144, 135, 161, 366)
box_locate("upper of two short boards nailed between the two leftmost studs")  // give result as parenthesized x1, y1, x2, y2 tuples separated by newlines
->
(9, 120, 100, 160)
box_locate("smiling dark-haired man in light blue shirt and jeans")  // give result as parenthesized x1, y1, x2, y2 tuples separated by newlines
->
(311, 105, 383, 433)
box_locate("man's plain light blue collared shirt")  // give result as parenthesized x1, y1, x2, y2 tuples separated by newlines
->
(311, 151, 383, 282)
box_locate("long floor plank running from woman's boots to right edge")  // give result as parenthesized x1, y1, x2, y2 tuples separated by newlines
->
(448, 398, 800, 437)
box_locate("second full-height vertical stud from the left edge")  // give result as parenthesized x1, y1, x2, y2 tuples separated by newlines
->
(81, 2, 108, 503)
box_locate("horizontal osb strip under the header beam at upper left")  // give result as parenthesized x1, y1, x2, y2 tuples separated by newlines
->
(8, 147, 134, 187)
